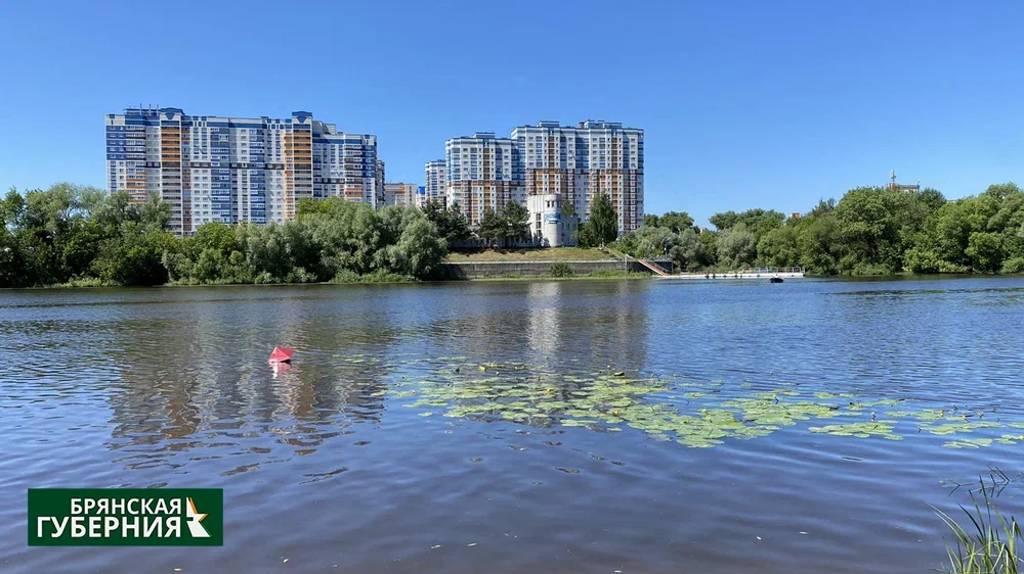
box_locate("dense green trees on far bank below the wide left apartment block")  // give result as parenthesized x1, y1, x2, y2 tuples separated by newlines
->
(0, 183, 459, 286)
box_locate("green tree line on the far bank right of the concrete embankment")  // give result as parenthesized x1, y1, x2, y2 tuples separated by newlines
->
(615, 183, 1024, 275)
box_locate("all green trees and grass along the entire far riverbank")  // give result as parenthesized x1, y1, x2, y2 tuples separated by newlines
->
(0, 183, 1024, 288)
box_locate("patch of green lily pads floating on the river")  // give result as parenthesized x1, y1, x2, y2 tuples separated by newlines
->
(390, 357, 1024, 448)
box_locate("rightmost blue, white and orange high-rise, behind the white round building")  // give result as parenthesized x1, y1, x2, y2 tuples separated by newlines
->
(512, 120, 643, 233)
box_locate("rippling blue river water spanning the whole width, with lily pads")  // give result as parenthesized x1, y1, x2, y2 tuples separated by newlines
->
(0, 277, 1024, 574)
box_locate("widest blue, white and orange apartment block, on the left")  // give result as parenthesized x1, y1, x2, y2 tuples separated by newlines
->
(106, 107, 383, 234)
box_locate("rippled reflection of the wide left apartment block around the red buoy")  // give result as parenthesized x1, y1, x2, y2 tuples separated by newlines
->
(103, 286, 399, 474)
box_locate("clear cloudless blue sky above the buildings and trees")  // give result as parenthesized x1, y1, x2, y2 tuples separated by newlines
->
(0, 0, 1024, 221)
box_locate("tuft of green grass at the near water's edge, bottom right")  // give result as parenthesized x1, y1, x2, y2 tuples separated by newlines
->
(936, 481, 1024, 574)
